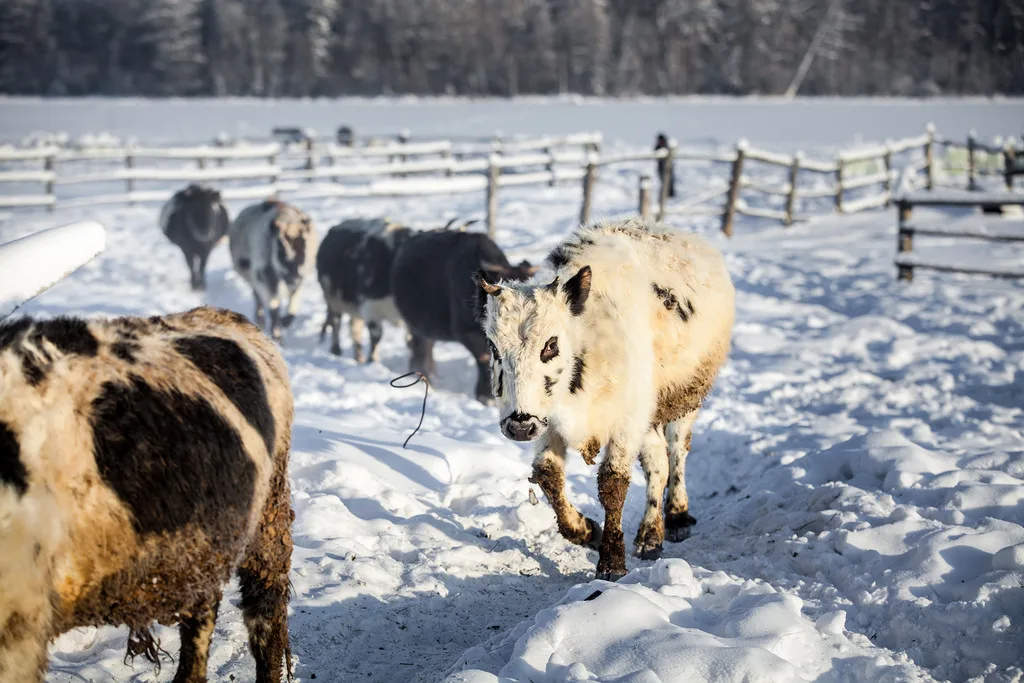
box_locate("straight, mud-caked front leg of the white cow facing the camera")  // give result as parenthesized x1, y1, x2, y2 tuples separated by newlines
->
(597, 439, 638, 581)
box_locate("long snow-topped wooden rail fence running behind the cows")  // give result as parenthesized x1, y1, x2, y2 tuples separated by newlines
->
(0, 126, 1007, 240)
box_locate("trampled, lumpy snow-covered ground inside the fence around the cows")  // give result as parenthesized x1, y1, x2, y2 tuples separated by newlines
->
(0, 124, 1024, 683)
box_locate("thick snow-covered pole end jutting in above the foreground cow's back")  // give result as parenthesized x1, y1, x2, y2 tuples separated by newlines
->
(0, 220, 106, 319)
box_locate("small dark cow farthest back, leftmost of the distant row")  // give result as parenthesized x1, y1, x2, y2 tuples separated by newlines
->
(160, 184, 229, 290)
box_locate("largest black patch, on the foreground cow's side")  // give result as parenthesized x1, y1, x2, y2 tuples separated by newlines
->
(89, 375, 256, 542)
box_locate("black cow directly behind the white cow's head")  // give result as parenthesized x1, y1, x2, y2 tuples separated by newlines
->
(391, 230, 538, 403)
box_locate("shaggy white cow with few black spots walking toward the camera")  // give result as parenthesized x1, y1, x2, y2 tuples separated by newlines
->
(477, 220, 734, 580)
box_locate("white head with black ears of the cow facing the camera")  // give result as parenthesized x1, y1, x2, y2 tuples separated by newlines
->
(475, 266, 591, 441)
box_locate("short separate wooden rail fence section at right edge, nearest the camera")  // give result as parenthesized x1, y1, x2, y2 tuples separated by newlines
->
(895, 190, 1024, 282)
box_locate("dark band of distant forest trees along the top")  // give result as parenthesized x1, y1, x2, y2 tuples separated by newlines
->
(0, 0, 1024, 96)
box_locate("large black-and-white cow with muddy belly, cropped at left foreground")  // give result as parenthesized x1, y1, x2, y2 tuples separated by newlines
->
(0, 307, 294, 683)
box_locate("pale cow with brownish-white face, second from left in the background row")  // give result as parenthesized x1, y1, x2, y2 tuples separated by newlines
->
(228, 200, 316, 339)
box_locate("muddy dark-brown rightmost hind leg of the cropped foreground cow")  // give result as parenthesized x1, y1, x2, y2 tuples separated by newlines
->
(238, 466, 294, 683)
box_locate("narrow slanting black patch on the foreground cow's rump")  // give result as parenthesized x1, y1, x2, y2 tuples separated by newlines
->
(174, 336, 274, 459)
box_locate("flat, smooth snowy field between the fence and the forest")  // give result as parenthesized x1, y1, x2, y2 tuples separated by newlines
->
(0, 97, 1024, 151)
